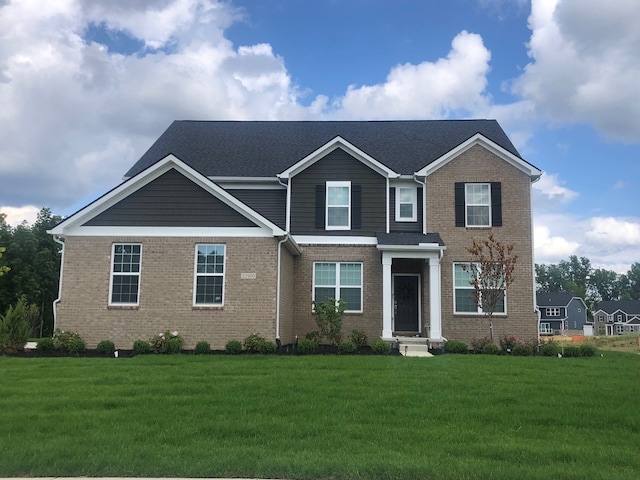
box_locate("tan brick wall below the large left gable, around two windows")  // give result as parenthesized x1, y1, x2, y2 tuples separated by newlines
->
(57, 237, 282, 349)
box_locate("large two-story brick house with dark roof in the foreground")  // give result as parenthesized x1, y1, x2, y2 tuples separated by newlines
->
(50, 120, 541, 348)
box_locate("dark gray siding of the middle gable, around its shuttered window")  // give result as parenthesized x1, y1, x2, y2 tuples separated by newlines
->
(290, 148, 387, 236)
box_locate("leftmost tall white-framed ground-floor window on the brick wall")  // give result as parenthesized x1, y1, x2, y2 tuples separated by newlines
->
(109, 243, 142, 305)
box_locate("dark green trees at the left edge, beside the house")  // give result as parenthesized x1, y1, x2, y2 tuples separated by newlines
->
(0, 208, 62, 337)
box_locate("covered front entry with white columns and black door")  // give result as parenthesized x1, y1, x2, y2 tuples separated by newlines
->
(377, 233, 445, 342)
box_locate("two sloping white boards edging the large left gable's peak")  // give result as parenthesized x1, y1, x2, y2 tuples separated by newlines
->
(50, 154, 285, 235)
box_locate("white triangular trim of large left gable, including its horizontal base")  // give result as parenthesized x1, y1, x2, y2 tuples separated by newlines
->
(49, 155, 286, 236)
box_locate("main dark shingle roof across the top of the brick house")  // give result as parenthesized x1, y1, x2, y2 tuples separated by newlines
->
(125, 120, 520, 177)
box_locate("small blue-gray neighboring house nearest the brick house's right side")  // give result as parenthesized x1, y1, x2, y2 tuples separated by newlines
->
(536, 292, 589, 335)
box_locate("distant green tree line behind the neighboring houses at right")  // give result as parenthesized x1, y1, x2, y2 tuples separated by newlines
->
(536, 255, 640, 312)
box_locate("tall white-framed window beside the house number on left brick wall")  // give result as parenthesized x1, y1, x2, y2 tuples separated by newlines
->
(193, 243, 225, 305)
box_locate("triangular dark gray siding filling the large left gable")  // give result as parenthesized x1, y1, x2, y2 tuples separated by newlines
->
(84, 169, 255, 227)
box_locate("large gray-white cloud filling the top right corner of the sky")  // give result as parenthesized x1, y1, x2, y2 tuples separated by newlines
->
(513, 0, 640, 142)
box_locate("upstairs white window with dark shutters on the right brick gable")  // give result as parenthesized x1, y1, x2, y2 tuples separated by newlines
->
(455, 182, 502, 228)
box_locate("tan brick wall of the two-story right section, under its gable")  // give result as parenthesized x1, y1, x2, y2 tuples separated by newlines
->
(426, 146, 537, 342)
